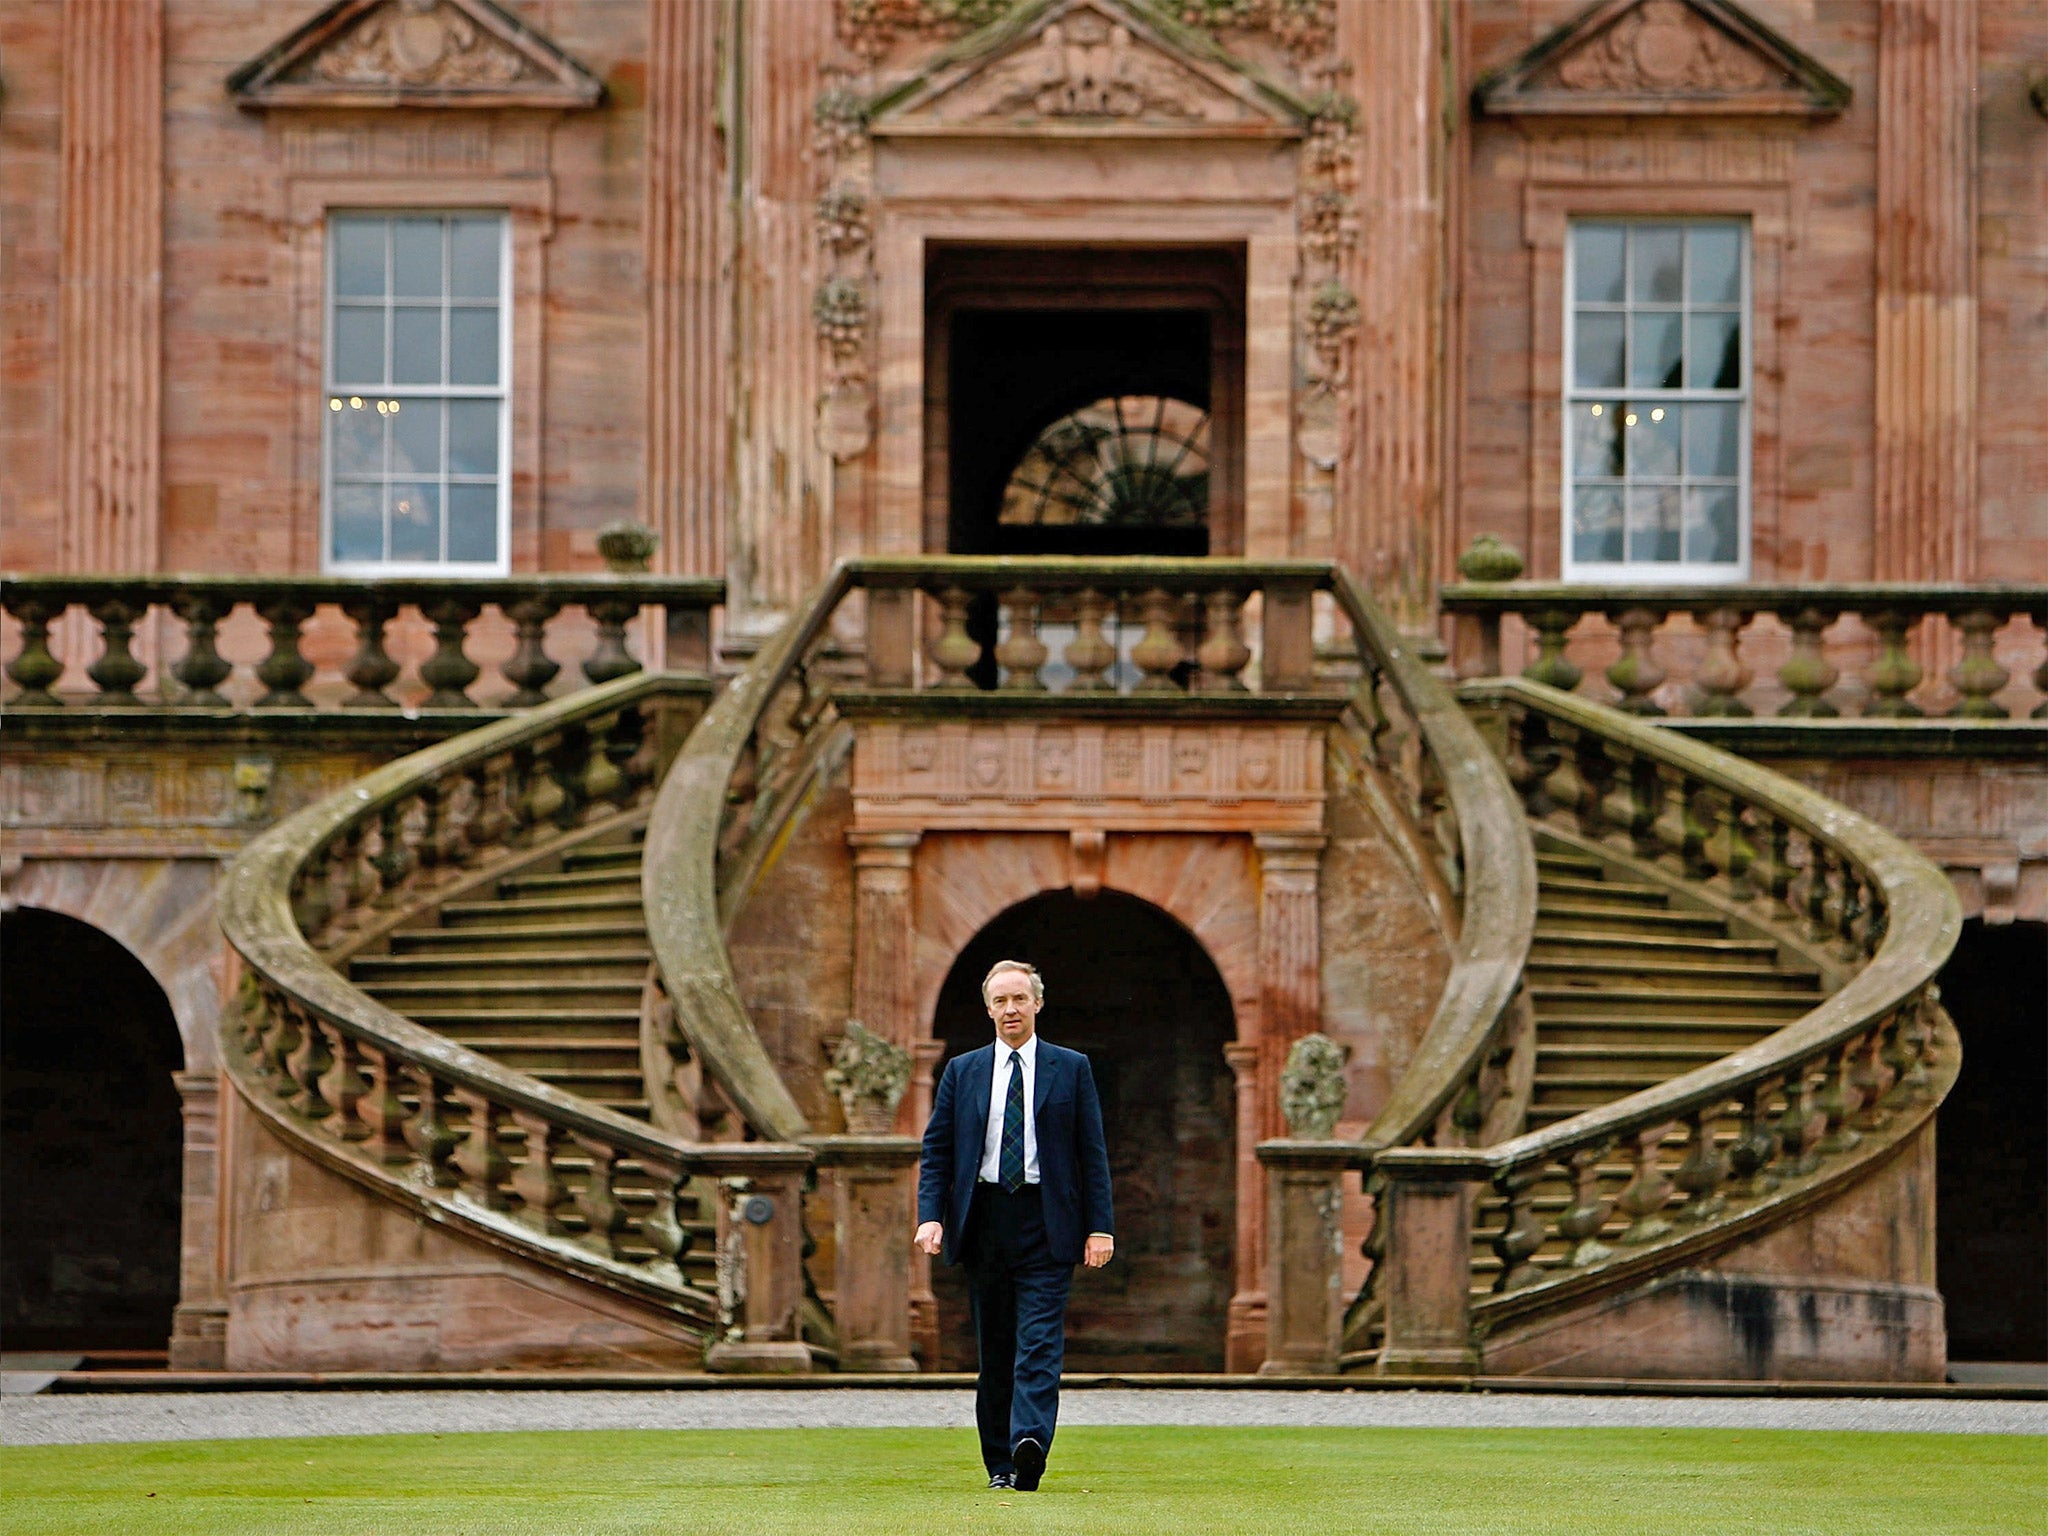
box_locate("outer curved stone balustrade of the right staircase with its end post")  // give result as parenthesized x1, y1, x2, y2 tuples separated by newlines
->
(1374, 680, 1962, 1370)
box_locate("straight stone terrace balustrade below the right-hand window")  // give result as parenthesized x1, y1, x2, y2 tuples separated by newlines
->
(1442, 582, 2048, 721)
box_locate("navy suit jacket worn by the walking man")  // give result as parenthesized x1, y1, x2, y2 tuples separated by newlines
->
(918, 1036, 1116, 1264)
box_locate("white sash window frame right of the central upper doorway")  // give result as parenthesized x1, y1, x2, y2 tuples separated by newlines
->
(1559, 213, 1757, 586)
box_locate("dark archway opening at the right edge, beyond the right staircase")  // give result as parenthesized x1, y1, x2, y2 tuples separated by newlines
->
(1935, 922, 2048, 1362)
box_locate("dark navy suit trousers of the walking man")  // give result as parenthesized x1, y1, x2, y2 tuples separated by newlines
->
(963, 1184, 1073, 1477)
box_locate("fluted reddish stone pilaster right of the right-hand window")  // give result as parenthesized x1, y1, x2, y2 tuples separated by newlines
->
(1872, 0, 1978, 582)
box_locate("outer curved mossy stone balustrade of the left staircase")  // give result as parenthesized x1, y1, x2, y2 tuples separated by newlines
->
(217, 674, 803, 1327)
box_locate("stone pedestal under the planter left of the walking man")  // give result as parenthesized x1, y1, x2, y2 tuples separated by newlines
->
(805, 1137, 918, 1370)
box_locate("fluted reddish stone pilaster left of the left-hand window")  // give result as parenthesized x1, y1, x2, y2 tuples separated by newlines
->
(57, 0, 164, 571)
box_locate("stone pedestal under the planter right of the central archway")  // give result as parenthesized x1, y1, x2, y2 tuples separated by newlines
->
(1257, 1139, 1358, 1376)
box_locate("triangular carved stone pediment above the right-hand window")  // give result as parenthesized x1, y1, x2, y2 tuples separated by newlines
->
(1473, 0, 1849, 117)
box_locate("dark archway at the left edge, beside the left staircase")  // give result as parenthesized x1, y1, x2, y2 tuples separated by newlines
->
(0, 907, 184, 1350)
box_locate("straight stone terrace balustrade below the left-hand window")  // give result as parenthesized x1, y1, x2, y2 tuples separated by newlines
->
(0, 575, 725, 711)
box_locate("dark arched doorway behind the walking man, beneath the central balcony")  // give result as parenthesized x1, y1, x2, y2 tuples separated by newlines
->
(932, 891, 1237, 1370)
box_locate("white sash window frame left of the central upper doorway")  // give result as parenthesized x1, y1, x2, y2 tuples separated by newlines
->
(319, 205, 518, 580)
